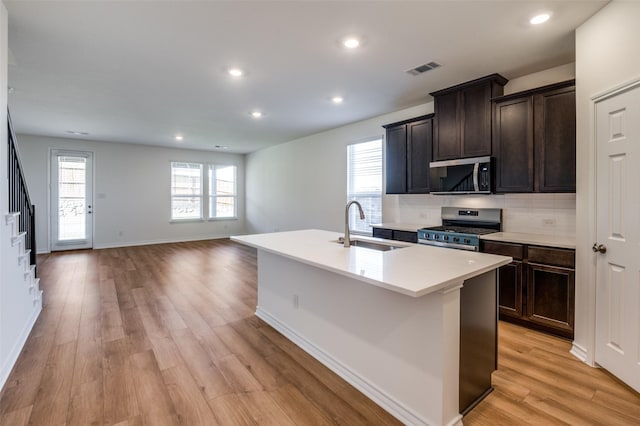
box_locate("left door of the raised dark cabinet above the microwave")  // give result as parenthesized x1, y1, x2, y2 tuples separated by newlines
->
(433, 92, 462, 161)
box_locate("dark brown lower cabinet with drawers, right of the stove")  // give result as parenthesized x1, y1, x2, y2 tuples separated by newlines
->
(481, 241, 575, 339)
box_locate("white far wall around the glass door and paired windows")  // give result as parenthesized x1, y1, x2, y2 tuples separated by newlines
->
(17, 135, 245, 252)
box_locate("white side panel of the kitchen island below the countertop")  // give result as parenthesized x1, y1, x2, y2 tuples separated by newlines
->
(256, 250, 461, 424)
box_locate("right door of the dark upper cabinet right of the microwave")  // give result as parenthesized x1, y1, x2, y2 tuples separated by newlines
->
(534, 86, 576, 192)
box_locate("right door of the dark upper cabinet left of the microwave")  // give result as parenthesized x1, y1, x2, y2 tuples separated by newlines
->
(407, 119, 433, 194)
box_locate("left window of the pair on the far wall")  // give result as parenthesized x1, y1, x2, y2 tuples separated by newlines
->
(171, 162, 203, 220)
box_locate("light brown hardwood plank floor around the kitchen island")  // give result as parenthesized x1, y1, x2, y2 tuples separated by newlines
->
(0, 240, 640, 426)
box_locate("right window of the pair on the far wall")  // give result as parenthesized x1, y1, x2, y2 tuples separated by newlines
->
(209, 165, 236, 219)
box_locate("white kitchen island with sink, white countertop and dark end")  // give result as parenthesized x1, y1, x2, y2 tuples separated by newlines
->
(232, 230, 511, 425)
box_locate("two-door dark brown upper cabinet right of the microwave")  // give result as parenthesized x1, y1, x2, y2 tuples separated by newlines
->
(492, 80, 576, 193)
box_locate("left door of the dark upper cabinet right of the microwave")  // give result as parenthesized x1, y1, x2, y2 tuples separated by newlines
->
(493, 96, 534, 192)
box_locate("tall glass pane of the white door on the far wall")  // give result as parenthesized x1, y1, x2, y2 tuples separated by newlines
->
(58, 156, 87, 241)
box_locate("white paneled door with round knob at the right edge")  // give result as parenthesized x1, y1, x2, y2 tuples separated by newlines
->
(594, 81, 640, 391)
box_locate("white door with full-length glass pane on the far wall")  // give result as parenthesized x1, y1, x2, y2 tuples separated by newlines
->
(51, 150, 93, 251)
